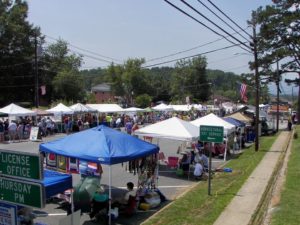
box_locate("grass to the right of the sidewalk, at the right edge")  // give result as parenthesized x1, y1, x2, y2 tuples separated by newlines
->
(271, 126, 300, 225)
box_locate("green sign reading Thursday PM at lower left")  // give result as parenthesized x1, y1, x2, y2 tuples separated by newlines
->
(0, 177, 45, 208)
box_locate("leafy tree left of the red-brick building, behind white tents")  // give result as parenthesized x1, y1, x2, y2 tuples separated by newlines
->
(39, 40, 84, 102)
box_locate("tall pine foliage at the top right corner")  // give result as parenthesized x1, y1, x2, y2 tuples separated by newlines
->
(256, 0, 300, 121)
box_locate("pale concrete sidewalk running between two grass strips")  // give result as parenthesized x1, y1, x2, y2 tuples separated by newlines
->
(214, 131, 289, 225)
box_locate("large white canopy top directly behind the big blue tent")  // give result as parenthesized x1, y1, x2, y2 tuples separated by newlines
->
(134, 117, 199, 141)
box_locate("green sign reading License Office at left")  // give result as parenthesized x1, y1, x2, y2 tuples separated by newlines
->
(0, 150, 43, 180)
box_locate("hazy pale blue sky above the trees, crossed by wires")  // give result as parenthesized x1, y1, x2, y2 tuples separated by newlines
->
(28, 0, 295, 93)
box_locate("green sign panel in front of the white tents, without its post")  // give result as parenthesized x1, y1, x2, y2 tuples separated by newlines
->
(199, 125, 224, 143)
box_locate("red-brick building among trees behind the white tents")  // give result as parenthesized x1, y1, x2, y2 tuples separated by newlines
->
(91, 83, 115, 104)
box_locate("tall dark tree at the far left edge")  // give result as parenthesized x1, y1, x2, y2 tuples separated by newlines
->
(0, 0, 40, 104)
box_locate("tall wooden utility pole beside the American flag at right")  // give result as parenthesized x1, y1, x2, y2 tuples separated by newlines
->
(252, 22, 260, 151)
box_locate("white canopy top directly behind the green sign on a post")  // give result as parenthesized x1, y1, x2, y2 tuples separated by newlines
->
(191, 113, 235, 134)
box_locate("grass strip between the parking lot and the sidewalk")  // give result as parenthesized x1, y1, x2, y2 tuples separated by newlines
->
(144, 136, 278, 225)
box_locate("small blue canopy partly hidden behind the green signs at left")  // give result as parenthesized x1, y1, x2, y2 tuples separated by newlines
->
(42, 170, 73, 199)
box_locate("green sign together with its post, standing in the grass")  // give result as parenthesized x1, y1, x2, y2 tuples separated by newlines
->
(199, 125, 224, 195)
